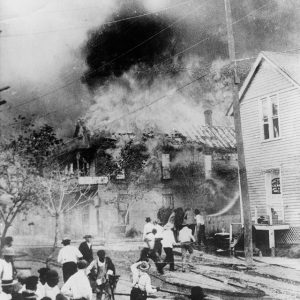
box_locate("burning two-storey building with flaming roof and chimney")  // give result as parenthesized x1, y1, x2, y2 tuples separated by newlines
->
(53, 111, 238, 236)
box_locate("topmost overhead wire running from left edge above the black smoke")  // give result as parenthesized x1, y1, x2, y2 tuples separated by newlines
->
(0, 0, 194, 38)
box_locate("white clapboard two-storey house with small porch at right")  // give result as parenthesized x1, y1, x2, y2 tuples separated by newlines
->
(239, 52, 300, 248)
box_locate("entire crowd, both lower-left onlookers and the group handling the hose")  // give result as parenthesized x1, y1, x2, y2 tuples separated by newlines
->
(0, 209, 205, 300)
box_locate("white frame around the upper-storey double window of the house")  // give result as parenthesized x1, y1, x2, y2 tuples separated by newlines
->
(258, 93, 282, 143)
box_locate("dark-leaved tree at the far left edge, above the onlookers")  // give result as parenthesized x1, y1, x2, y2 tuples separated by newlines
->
(0, 119, 61, 247)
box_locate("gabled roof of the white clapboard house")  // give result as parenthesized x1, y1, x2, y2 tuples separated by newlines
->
(239, 51, 300, 100)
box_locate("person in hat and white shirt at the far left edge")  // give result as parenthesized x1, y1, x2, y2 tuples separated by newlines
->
(0, 247, 17, 294)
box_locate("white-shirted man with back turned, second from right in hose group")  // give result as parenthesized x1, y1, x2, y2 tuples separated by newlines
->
(178, 225, 195, 272)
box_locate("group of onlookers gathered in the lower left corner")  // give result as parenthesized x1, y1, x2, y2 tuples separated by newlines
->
(0, 235, 118, 300)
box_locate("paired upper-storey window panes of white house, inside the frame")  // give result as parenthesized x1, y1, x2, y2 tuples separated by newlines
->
(261, 95, 279, 140)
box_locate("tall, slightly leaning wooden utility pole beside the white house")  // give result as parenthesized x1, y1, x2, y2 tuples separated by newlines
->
(224, 0, 253, 266)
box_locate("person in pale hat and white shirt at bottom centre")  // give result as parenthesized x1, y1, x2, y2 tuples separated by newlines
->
(130, 261, 159, 300)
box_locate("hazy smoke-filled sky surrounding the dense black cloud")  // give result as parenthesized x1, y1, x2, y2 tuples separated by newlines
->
(0, 0, 300, 137)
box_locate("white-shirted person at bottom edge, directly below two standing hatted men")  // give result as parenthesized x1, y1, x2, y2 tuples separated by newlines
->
(61, 260, 93, 300)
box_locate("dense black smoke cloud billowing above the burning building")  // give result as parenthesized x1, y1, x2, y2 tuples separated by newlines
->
(83, 4, 182, 88)
